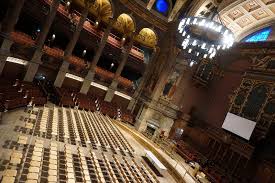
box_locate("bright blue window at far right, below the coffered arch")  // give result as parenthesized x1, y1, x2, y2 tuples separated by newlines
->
(245, 27, 272, 42)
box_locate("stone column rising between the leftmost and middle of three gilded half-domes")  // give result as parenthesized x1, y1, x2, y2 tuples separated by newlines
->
(80, 19, 115, 94)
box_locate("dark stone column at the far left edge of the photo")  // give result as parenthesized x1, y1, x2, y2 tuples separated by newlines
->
(0, 0, 25, 75)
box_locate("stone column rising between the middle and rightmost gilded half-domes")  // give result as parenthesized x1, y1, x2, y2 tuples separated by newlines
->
(104, 34, 134, 102)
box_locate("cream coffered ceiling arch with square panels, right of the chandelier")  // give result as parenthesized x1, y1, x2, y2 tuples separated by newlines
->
(220, 0, 275, 40)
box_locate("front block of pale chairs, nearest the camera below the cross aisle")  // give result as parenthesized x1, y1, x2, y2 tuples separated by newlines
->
(1, 135, 159, 183)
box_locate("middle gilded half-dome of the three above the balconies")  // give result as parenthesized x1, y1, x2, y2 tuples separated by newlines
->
(114, 13, 136, 35)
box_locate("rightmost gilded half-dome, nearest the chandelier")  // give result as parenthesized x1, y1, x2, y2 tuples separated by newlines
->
(136, 28, 157, 48)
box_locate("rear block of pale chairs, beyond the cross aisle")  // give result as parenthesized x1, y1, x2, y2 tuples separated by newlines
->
(26, 106, 134, 157)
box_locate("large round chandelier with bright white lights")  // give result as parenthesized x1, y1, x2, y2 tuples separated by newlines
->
(178, 17, 234, 66)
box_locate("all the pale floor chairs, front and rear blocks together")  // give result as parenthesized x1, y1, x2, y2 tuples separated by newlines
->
(0, 106, 159, 183)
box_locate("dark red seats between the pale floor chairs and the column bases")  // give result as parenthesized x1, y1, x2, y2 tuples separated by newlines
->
(56, 88, 134, 125)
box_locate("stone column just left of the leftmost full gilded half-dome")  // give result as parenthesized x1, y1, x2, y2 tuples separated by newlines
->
(54, 7, 89, 88)
